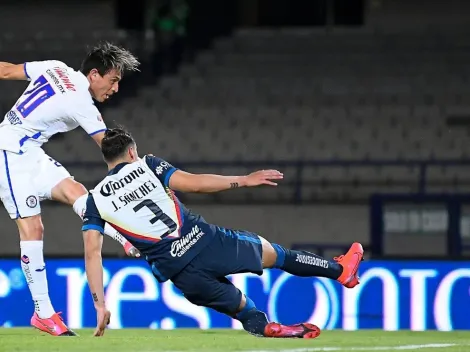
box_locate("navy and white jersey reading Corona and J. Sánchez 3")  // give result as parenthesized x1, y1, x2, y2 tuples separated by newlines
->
(82, 155, 215, 281)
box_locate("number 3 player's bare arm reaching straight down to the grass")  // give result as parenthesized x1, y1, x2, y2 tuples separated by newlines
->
(83, 230, 111, 336)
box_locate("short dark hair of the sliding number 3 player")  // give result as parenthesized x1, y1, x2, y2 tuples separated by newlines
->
(101, 126, 135, 162)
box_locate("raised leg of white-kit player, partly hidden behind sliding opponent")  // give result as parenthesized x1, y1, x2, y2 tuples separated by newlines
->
(51, 177, 140, 257)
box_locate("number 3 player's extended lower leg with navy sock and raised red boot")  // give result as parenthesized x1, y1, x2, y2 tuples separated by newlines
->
(260, 237, 364, 288)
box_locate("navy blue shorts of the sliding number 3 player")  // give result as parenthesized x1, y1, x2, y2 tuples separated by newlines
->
(171, 227, 263, 316)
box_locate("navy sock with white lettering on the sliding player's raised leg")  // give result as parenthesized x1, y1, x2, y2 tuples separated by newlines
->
(272, 243, 343, 280)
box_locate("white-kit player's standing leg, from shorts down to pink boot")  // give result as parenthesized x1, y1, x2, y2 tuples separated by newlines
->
(0, 148, 76, 335)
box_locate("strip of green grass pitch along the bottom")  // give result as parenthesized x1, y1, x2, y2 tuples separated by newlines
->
(0, 328, 470, 352)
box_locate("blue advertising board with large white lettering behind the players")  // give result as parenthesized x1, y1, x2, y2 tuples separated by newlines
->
(0, 258, 470, 331)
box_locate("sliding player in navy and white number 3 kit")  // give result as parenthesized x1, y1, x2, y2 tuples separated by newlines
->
(82, 128, 364, 338)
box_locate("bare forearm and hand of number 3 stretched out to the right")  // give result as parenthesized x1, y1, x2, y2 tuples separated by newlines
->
(169, 170, 284, 193)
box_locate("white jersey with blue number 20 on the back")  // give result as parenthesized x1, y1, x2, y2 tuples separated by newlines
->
(0, 61, 106, 154)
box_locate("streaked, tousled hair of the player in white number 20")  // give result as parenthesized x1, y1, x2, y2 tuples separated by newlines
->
(80, 42, 140, 76)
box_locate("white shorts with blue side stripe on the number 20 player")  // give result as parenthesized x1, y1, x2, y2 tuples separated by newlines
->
(0, 148, 71, 219)
